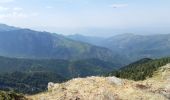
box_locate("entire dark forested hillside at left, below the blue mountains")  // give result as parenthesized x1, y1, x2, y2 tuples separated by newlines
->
(0, 57, 116, 94)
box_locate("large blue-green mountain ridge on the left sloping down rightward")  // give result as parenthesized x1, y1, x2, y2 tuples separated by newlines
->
(0, 24, 124, 66)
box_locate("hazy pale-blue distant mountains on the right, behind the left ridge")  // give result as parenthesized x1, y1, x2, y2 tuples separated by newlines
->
(68, 34, 170, 62)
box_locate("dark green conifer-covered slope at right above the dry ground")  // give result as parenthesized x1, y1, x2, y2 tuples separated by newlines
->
(107, 57, 170, 81)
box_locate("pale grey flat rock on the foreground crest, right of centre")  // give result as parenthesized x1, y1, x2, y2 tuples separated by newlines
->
(106, 76, 123, 85)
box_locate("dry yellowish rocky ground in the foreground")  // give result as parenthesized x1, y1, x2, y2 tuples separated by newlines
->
(27, 64, 170, 100)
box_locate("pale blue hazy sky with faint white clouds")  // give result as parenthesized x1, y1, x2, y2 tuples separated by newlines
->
(0, 0, 170, 36)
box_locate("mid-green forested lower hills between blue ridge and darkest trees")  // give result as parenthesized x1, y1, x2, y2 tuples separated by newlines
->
(0, 57, 117, 78)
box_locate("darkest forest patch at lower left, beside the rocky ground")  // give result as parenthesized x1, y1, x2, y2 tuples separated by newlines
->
(0, 72, 66, 94)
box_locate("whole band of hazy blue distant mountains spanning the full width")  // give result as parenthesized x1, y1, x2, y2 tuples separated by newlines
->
(0, 24, 170, 66)
